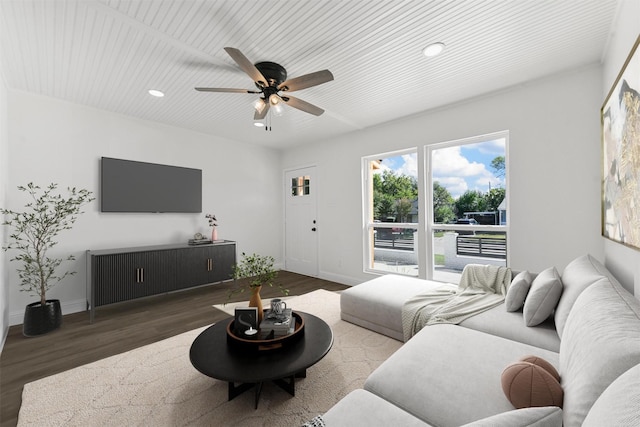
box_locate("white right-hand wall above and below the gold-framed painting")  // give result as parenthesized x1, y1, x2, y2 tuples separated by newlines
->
(601, 0, 640, 297)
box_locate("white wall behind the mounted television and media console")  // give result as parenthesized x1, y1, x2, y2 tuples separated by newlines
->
(6, 91, 283, 324)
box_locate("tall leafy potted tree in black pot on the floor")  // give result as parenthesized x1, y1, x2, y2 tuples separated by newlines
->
(0, 182, 94, 336)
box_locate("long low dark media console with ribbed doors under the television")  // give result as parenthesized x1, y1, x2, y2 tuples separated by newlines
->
(87, 240, 236, 322)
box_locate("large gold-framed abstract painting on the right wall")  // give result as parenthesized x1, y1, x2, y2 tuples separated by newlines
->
(600, 35, 640, 250)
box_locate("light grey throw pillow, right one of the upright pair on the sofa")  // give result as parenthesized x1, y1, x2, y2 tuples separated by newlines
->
(524, 267, 562, 326)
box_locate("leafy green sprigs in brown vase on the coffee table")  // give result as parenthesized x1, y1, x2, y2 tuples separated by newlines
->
(229, 252, 289, 323)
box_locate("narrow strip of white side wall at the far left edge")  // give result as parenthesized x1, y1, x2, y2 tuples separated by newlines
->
(0, 76, 9, 353)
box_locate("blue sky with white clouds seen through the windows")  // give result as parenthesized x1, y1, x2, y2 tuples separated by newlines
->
(382, 138, 505, 198)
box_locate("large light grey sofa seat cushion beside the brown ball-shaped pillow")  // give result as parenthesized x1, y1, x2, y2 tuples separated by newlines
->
(364, 324, 558, 426)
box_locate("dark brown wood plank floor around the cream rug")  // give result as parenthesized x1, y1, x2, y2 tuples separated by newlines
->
(0, 271, 346, 427)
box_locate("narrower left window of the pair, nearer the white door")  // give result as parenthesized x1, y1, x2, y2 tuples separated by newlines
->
(363, 149, 420, 276)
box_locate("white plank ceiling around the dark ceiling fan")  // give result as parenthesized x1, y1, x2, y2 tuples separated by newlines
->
(0, 0, 620, 148)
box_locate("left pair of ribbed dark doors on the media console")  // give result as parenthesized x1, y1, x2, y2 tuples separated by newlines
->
(93, 251, 176, 306)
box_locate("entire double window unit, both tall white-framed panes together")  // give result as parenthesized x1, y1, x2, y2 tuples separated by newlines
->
(362, 131, 509, 283)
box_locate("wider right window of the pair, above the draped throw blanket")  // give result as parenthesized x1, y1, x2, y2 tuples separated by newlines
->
(425, 132, 508, 283)
